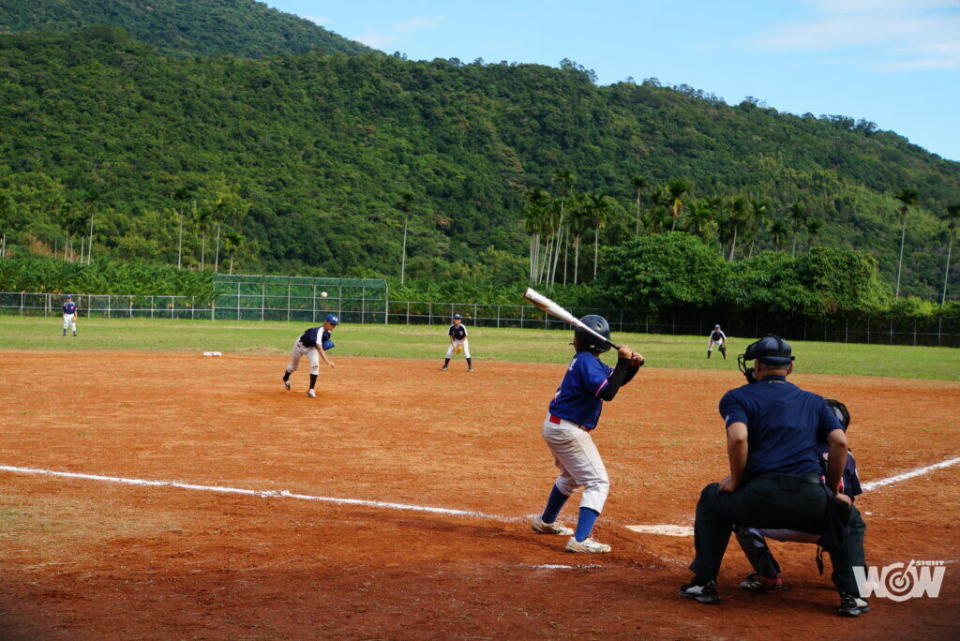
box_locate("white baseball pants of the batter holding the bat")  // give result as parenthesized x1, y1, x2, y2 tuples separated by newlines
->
(543, 414, 610, 512)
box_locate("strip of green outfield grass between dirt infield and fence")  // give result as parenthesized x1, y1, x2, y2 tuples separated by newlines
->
(0, 316, 960, 381)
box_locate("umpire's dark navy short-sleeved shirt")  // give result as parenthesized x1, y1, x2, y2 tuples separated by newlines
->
(720, 376, 840, 481)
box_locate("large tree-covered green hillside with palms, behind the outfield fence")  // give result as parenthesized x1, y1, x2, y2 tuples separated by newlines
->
(0, 28, 960, 299)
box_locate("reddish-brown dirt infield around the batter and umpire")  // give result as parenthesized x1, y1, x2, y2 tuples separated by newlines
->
(0, 351, 960, 641)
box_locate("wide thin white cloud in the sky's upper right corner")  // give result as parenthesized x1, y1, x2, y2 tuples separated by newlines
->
(756, 0, 960, 71)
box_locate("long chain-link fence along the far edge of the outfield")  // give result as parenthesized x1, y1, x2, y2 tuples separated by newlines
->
(0, 290, 960, 347)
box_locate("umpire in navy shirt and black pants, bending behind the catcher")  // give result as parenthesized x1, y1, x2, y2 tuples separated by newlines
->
(680, 336, 869, 616)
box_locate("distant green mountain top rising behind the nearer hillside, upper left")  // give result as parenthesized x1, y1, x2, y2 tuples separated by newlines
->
(0, 0, 371, 58)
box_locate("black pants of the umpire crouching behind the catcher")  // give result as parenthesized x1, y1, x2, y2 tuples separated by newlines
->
(690, 474, 863, 593)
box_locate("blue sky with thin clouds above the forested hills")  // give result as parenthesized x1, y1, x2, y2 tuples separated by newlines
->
(266, 0, 960, 161)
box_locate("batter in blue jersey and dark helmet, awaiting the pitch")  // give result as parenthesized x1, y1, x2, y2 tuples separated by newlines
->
(531, 314, 643, 554)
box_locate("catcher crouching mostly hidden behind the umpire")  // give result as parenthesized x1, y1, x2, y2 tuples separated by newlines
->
(734, 398, 869, 596)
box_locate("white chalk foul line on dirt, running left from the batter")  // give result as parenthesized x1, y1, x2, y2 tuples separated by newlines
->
(0, 465, 518, 521)
